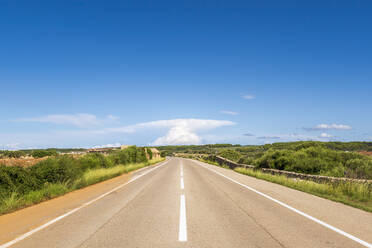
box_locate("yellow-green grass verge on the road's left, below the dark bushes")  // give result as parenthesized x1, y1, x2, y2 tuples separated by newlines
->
(0, 158, 164, 215)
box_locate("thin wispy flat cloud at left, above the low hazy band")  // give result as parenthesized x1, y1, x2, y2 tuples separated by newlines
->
(14, 113, 119, 127)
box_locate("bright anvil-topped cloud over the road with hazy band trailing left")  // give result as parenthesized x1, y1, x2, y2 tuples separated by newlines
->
(0, 118, 235, 147)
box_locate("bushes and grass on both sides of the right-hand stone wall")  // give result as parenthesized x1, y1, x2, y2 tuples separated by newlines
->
(162, 141, 372, 212)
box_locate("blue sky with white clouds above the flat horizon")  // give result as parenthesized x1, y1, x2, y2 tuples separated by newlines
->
(0, 0, 372, 149)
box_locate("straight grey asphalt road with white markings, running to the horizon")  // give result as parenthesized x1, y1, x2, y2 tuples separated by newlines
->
(0, 158, 372, 248)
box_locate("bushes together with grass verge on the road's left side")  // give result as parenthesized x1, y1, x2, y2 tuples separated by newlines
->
(0, 146, 164, 214)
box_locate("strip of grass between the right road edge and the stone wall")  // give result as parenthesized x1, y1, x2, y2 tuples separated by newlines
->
(235, 168, 372, 212)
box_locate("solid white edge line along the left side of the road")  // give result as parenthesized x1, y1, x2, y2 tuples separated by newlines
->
(0, 160, 170, 248)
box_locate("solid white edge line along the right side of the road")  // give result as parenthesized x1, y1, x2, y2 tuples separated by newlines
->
(193, 160, 372, 248)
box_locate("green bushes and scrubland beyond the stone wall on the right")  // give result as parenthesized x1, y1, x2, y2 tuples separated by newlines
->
(158, 141, 372, 179)
